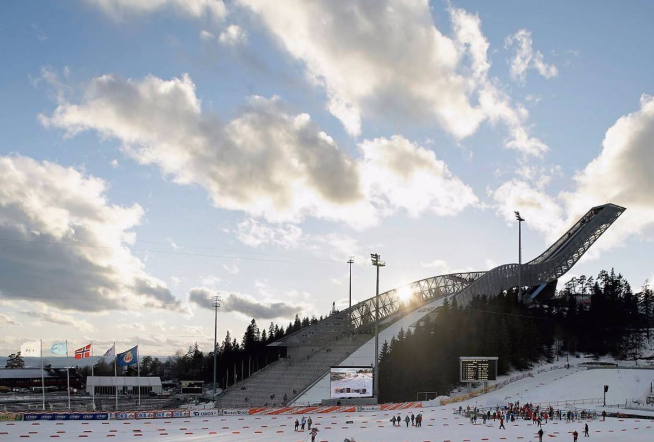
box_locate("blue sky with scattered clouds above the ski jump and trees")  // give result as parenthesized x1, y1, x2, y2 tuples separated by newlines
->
(0, 0, 654, 355)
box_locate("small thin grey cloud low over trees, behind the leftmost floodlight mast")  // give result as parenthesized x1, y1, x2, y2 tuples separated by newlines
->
(189, 288, 304, 320)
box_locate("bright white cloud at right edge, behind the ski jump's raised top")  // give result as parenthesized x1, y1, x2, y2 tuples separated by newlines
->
(491, 95, 654, 258)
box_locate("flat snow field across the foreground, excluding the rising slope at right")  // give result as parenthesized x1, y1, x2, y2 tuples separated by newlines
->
(0, 407, 654, 442)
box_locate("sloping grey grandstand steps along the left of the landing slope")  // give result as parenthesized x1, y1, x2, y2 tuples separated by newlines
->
(216, 334, 370, 408)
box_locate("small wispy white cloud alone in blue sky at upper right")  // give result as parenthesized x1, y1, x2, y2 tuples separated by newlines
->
(504, 29, 559, 84)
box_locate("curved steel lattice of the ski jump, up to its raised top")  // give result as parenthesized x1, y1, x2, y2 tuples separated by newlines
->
(269, 204, 626, 346)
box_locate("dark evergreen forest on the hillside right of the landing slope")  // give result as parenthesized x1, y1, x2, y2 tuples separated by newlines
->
(379, 270, 654, 402)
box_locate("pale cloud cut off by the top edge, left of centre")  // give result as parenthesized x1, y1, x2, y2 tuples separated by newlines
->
(86, 0, 227, 22)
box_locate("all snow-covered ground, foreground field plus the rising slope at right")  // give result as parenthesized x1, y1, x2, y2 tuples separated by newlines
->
(5, 369, 654, 442)
